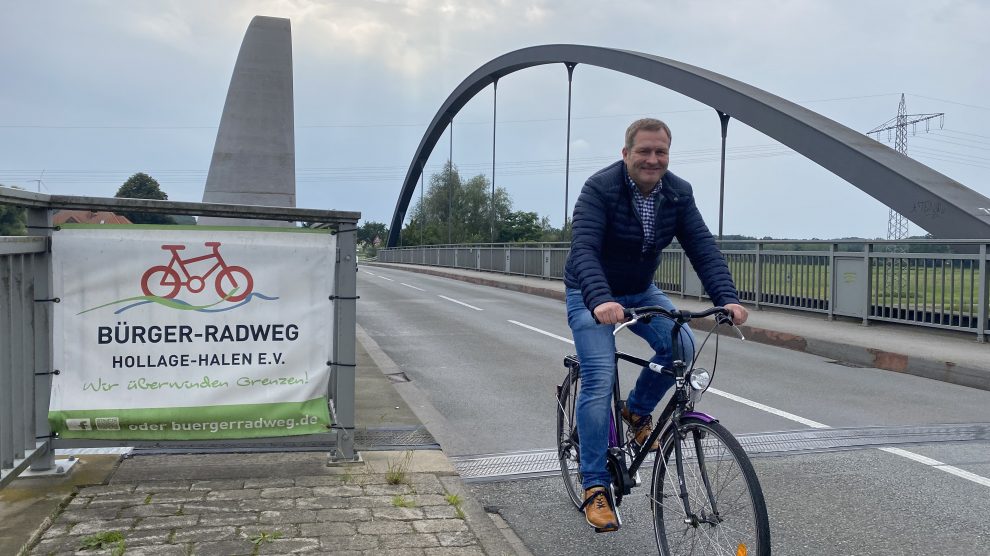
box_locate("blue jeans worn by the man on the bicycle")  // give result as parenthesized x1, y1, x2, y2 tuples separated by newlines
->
(567, 285, 694, 488)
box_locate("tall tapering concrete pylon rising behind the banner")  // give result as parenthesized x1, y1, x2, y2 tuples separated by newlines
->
(199, 16, 296, 226)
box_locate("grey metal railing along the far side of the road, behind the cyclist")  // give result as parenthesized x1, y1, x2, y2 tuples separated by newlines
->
(378, 240, 990, 342)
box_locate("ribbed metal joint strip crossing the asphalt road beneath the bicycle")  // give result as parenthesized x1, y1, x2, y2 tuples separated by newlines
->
(450, 423, 990, 482)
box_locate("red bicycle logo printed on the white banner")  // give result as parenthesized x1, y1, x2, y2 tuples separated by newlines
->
(141, 241, 254, 301)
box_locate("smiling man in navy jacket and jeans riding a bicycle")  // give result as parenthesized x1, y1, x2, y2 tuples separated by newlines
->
(564, 118, 748, 531)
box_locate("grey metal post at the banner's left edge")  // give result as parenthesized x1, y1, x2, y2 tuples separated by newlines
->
(27, 208, 55, 471)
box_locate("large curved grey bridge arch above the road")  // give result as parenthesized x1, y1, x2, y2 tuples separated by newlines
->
(388, 44, 990, 247)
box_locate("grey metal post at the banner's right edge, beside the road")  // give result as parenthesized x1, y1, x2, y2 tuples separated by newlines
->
(330, 223, 357, 461)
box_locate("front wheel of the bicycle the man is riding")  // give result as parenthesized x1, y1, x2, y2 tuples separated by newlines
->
(651, 418, 770, 556)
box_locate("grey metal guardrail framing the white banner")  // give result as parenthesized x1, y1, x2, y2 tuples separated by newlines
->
(0, 187, 361, 488)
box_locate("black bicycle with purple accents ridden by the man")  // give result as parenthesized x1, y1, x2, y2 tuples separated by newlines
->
(557, 307, 770, 556)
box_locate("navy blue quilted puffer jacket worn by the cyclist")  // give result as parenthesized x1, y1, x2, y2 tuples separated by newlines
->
(564, 160, 739, 311)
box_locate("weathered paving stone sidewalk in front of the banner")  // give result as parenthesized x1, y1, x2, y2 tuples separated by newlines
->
(28, 452, 514, 556)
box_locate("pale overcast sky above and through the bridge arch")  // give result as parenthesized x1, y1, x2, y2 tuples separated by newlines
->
(0, 0, 990, 238)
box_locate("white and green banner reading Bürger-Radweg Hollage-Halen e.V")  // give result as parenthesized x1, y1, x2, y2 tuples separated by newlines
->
(49, 226, 336, 440)
